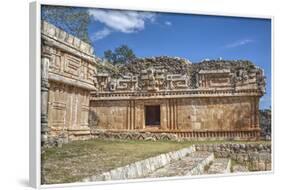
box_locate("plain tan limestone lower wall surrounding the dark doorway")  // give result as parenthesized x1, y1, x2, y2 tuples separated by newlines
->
(90, 97, 259, 139)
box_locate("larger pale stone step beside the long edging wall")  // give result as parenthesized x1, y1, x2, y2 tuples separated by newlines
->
(146, 151, 214, 177)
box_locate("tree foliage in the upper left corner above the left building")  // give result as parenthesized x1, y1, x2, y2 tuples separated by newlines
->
(41, 5, 90, 43)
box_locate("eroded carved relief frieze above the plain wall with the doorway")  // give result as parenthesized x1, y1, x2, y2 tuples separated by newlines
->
(92, 61, 265, 93)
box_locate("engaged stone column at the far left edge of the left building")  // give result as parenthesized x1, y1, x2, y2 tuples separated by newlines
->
(41, 46, 51, 146)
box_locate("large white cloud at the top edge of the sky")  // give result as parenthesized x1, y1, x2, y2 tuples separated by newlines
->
(89, 9, 156, 33)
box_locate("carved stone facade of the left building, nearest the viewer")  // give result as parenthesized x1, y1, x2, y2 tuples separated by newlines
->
(41, 22, 96, 144)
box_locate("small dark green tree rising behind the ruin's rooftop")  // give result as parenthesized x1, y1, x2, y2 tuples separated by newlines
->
(104, 45, 136, 64)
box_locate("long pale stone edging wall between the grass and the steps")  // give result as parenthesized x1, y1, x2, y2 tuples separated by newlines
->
(83, 145, 195, 182)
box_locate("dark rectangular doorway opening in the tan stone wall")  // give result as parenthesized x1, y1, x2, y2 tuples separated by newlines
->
(145, 105, 160, 126)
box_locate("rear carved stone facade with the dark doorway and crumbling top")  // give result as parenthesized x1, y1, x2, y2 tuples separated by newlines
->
(90, 57, 265, 140)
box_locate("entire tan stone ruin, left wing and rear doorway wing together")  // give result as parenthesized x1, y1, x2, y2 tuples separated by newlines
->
(41, 21, 265, 143)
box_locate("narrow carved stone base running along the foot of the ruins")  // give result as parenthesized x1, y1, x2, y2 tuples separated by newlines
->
(43, 129, 259, 146)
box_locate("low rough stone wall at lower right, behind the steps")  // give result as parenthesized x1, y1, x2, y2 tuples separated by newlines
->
(195, 143, 271, 171)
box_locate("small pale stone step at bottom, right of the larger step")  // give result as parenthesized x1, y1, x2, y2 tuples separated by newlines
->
(205, 158, 231, 174)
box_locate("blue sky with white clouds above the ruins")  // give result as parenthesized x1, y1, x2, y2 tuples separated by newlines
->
(89, 9, 271, 109)
